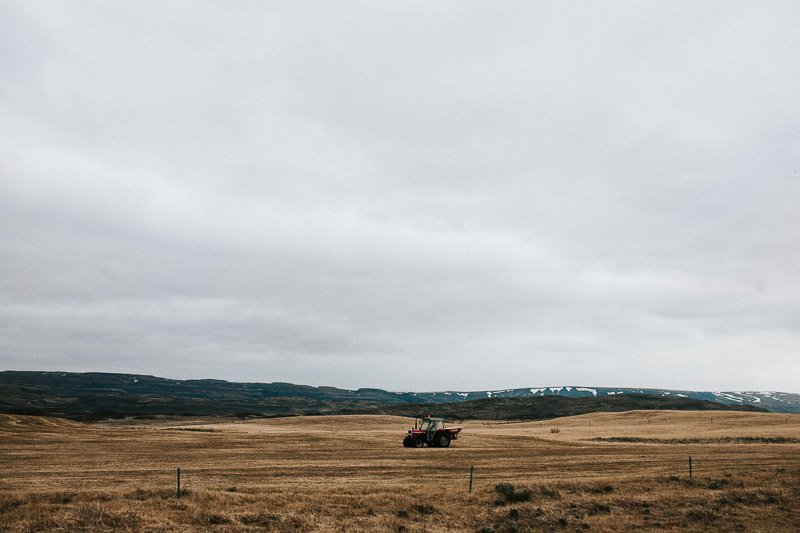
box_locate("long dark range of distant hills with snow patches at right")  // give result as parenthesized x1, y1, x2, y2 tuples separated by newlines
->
(0, 371, 800, 420)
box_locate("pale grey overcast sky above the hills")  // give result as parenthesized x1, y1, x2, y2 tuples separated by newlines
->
(0, 0, 800, 392)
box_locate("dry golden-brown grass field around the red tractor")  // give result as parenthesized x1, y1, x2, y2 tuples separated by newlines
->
(0, 411, 800, 532)
